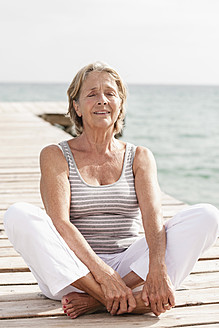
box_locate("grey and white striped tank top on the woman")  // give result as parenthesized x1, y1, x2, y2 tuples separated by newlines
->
(59, 141, 142, 254)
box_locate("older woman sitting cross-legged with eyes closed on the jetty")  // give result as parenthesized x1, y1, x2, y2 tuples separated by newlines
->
(4, 63, 219, 318)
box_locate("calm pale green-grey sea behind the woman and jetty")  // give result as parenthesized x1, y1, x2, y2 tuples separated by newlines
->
(0, 83, 219, 208)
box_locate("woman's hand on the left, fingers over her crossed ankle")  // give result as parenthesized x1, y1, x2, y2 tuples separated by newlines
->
(95, 267, 136, 315)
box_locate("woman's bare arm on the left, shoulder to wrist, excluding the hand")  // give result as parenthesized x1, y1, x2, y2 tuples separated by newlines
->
(40, 145, 100, 272)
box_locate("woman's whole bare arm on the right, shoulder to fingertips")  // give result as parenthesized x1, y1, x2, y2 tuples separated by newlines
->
(133, 147, 175, 315)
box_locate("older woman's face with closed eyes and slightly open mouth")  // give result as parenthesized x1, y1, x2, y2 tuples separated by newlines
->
(74, 71, 121, 130)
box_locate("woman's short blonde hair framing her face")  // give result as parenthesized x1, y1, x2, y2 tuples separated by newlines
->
(67, 62, 127, 135)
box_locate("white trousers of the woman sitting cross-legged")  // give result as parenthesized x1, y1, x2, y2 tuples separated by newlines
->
(4, 203, 219, 300)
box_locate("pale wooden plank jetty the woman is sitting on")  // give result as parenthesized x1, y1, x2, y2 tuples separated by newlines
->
(0, 102, 219, 328)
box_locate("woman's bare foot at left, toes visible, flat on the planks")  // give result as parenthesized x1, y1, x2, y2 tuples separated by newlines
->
(62, 292, 103, 319)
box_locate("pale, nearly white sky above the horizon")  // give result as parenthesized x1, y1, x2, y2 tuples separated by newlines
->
(0, 0, 219, 85)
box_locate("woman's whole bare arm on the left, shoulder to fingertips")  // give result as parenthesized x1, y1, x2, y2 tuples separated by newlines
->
(40, 145, 135, 312)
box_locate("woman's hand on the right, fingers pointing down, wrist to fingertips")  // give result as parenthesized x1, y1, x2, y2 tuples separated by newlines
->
(142, 267, 175, 316)
